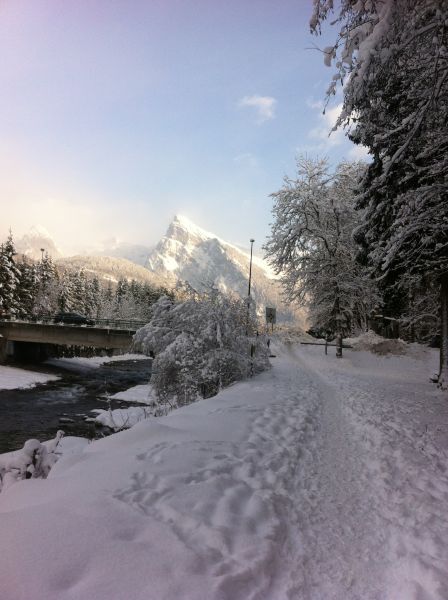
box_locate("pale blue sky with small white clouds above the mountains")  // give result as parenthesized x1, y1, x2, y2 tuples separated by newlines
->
(0, 0, 363, 254)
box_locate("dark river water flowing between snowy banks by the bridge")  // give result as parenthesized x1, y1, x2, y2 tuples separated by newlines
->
(0, 360, 151, 453)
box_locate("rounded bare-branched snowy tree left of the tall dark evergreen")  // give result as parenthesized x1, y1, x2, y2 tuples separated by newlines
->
(265, 158, 379, 334)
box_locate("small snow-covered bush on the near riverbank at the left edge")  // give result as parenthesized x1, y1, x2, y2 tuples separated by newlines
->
(0, 431, 64, 491)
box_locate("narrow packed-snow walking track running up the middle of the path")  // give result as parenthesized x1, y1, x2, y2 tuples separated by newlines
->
(286, 350, 387, 600)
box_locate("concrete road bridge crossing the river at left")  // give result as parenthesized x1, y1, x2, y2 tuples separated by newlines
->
(0, 320, 144, 362)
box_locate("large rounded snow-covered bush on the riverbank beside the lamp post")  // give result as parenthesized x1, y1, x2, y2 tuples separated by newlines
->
(134, 290, 269, 406)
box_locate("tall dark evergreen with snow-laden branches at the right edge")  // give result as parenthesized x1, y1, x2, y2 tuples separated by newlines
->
(311, 0, 448, 385)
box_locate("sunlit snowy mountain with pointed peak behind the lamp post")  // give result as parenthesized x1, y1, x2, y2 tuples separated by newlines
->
(146, 215, 304, 320)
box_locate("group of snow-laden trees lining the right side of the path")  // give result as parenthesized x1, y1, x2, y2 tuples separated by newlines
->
(267, 0, 448, 387)
